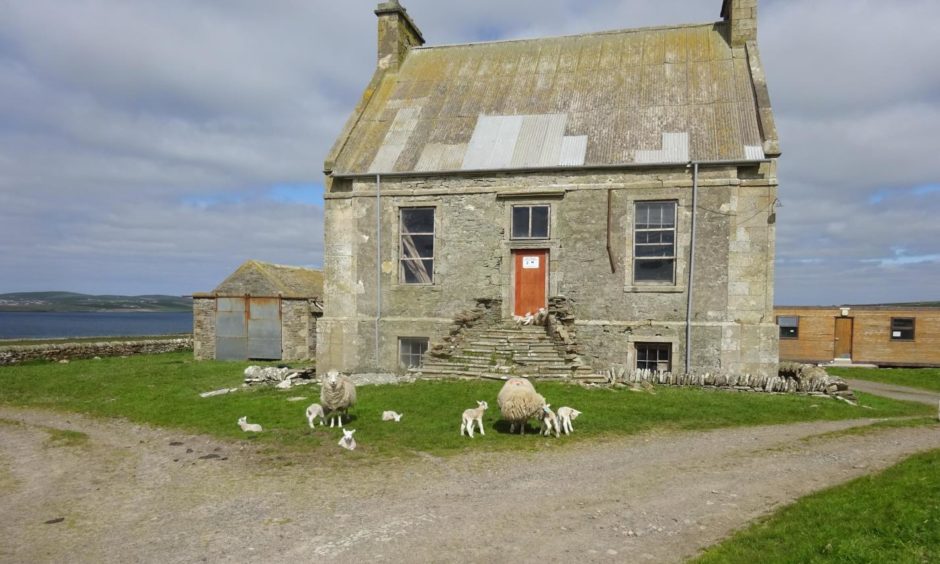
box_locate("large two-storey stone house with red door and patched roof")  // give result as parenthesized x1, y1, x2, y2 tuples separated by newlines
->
(317, 0, 780, 375)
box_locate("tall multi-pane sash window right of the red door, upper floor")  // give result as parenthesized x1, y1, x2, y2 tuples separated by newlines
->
(633, 202, 676, 284)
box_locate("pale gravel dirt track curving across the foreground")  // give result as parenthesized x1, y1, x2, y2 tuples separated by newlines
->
(0, 408, 940, 563)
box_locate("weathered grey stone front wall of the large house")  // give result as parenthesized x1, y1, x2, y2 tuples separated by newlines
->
(319, 164, 777, 374)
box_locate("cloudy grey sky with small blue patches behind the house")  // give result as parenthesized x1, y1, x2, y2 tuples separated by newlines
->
(0, 0, 940, 305)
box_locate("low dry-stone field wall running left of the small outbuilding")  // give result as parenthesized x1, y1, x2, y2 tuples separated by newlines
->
(0, 337, 193, 366)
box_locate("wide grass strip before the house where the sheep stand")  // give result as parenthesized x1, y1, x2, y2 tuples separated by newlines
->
(0, 352, 935, 456)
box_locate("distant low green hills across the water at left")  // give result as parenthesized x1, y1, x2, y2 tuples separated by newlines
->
(0, 292, 193, 312)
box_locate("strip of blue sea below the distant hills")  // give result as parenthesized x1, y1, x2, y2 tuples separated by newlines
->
(0, 311, 193, 339)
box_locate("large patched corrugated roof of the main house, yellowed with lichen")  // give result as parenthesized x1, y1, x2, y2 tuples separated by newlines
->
(328, 22, 776, 175)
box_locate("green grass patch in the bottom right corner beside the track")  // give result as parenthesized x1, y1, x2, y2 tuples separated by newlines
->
(694, 451, 940, 564)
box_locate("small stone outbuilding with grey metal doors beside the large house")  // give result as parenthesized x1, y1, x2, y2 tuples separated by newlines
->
(193, 260, 323, 360)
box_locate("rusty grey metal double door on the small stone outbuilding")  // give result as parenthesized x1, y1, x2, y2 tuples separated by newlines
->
(215, 296, 281, 360)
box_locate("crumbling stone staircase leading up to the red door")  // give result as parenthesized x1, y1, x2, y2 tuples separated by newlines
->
(412, 324, 594, 380)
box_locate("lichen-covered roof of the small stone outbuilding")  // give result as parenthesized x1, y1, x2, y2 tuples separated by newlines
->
(212, 260, 323, 298)
